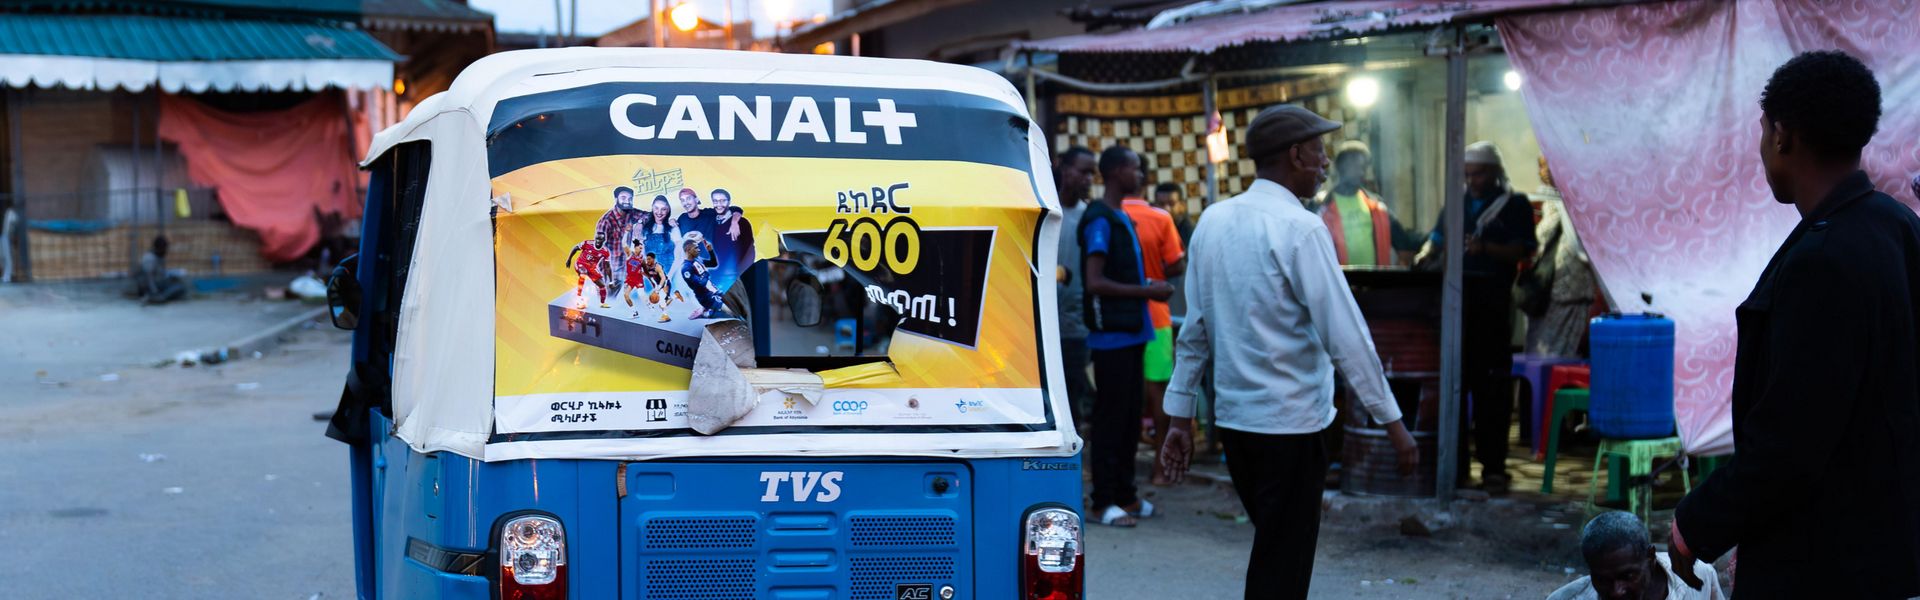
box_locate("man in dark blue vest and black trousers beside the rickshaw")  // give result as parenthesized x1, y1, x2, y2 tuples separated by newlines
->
(1079, 146, 1173, 527)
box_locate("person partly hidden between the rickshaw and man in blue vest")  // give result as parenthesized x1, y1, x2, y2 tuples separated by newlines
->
(1054, 146, 1094, 423)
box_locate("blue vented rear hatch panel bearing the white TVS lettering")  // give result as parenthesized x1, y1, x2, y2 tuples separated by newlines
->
(620, 462, 979, 600)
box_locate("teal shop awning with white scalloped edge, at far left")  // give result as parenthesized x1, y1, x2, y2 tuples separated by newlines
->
(0, 13, 399, 92)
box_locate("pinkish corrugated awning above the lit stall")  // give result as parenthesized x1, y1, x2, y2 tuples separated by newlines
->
(1014, 0, 1636, 54)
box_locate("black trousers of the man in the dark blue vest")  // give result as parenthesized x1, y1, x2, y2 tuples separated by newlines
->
(1087, 346, 1146, 507)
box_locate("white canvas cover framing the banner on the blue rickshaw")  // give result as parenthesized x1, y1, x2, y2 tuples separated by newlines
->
(363, 48, 1081, 460)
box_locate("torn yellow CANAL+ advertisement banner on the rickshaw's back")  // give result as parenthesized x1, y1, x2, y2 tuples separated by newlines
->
(474, 83, 1056, 444)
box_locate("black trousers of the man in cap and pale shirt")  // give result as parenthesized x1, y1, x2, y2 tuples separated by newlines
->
(1217, 429, 1327, 600)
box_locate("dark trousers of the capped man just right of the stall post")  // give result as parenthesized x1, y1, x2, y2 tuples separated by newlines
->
(1457, 277, 1513, 479)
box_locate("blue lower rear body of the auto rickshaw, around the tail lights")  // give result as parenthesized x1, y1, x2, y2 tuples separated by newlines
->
(360, 405, 1081, 600)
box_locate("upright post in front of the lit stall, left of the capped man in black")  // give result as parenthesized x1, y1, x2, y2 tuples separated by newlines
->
(1434, 29, 1467, 502)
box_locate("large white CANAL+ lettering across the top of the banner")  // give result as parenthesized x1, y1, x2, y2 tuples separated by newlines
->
(607, 94, 920, 146)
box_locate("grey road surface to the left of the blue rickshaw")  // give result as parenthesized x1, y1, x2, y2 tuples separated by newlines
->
(0, 323, 353, 598)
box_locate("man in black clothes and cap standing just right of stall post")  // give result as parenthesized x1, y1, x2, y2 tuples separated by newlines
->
(1415, 142, 1540, 494)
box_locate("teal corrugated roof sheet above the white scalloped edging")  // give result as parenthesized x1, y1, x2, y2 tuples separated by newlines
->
(0, 13, 399, 62)
